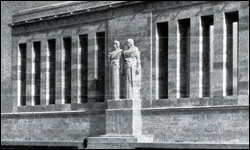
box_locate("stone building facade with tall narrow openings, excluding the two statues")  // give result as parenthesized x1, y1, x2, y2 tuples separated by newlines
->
(1, 1, 249, 148)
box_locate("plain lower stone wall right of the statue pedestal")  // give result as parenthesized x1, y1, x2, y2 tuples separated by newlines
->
(142, 106, 249, 144)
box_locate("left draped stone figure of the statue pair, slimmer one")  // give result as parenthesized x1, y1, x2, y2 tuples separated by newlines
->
(109, 41, 122, 100)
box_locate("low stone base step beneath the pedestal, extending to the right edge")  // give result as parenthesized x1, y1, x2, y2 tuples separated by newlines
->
(87, 136, 249, 149)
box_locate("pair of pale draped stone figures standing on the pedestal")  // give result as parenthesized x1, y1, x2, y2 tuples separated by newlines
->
(109, 39, 141, 99)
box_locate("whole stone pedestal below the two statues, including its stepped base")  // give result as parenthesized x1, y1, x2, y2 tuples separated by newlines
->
(88, 99, 147, 149)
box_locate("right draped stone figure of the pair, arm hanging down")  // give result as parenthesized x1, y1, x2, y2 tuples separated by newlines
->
(123, 39, 141, 99)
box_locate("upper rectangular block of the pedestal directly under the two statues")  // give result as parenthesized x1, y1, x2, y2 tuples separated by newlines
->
(106, 99, 141, 136)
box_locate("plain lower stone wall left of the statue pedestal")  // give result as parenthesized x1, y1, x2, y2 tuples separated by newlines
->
(1, 111, 105, 143)
